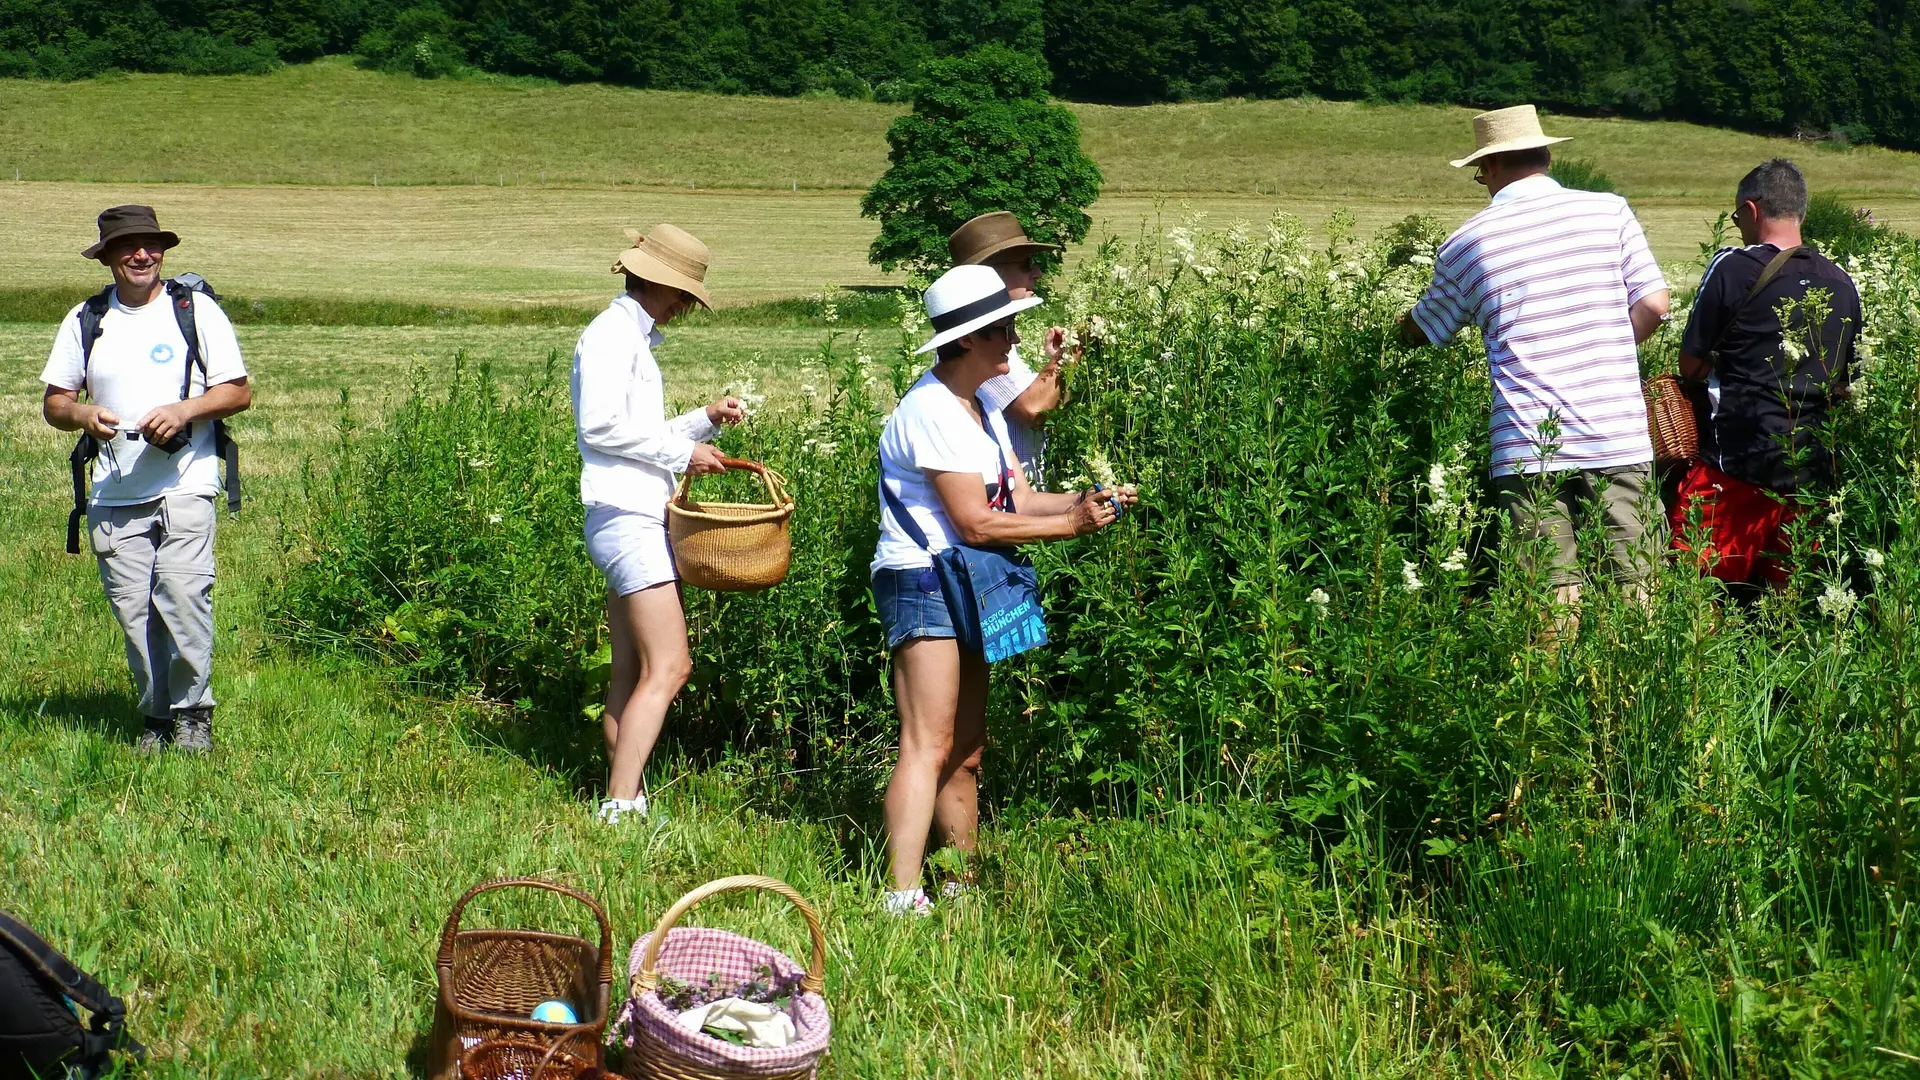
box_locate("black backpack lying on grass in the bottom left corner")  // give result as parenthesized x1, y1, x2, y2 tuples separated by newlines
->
(0, 911, 146, 1080)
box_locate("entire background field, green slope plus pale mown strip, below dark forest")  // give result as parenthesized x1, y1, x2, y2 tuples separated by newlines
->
(0, 60, 1920, 306)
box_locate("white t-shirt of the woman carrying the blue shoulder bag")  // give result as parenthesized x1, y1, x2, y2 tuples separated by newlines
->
(872, 371, 1014, 571)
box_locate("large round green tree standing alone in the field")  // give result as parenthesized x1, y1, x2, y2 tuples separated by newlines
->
(860, 44, 1100, 273)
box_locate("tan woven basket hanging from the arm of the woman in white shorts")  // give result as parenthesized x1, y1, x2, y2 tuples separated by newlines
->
(666, 457, 793, 592)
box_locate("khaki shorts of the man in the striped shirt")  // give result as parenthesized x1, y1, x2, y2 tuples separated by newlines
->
(1494, 465, 1667, 586)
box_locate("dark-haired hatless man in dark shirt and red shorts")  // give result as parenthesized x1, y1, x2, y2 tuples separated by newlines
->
(1670, 158, 1860, 584)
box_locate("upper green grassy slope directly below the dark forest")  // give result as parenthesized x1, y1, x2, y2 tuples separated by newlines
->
(11, 58, 1920, 202)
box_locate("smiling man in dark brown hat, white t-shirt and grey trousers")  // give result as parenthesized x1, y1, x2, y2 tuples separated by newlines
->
(40, 206, 253, 753)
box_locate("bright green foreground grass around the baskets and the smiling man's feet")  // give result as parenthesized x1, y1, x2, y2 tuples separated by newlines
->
(0, 315, 1549, 1078)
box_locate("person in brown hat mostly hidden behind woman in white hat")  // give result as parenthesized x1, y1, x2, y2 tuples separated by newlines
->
(947, 209, 1071, 478)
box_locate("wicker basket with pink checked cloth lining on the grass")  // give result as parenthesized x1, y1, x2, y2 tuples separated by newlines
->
(620, 874, 833, 1080)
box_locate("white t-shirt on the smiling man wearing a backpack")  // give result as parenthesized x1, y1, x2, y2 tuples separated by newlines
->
(40, 288, 246, 505)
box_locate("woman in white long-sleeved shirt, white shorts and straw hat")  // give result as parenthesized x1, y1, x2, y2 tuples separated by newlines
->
(570, 225, 745, 824)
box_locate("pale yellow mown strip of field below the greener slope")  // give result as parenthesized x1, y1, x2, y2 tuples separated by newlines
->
(0, 173, 1920, 307)
